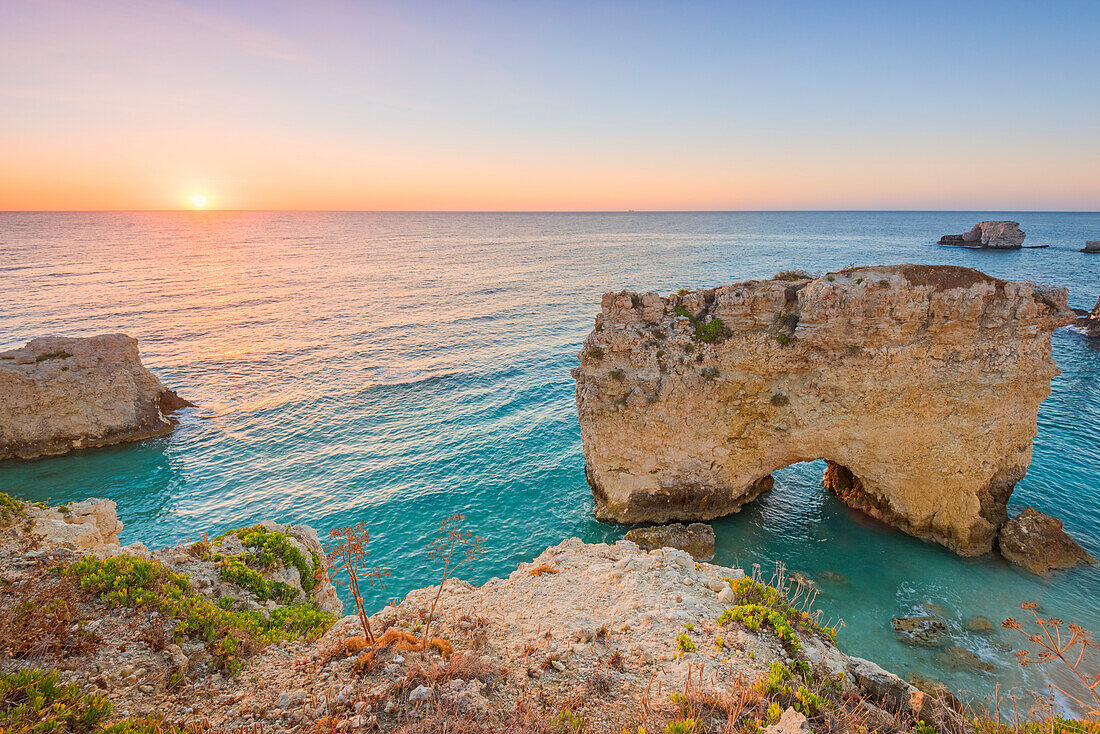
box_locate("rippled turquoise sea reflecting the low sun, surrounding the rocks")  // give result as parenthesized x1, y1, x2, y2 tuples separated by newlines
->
(0, 212, 1100, 713)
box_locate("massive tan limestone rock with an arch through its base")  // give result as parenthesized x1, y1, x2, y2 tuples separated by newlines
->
(573, 265, 1074, 555)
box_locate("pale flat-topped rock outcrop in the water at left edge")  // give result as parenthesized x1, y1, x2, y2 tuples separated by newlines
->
(0, 333, 190, 460)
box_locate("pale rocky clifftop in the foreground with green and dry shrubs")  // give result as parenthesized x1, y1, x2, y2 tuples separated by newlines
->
(0, 495, 960, 732)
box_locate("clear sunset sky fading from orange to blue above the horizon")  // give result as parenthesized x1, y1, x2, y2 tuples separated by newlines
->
(0, 0, 1100, 210)
